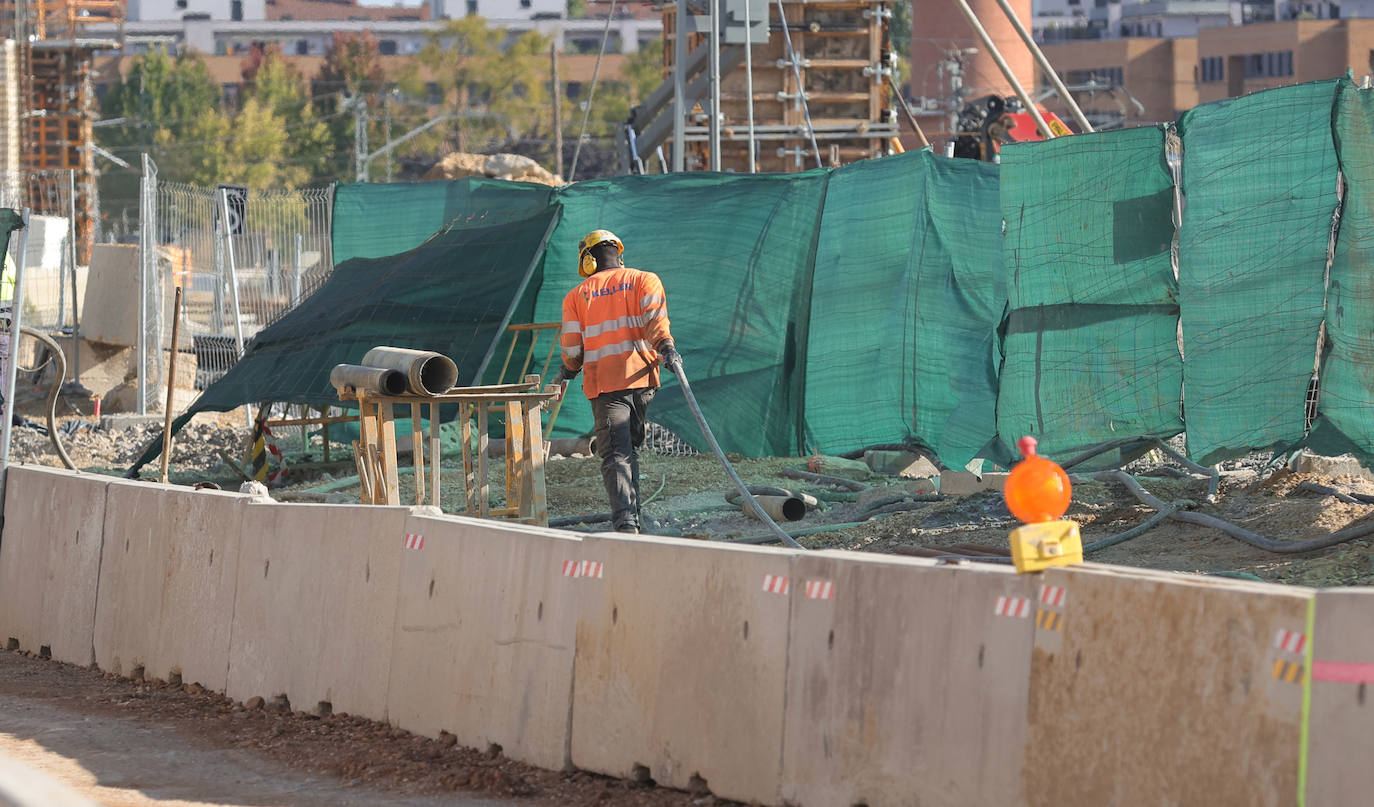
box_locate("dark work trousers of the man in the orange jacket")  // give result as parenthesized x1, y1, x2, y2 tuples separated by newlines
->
(592, 386, 657, 531)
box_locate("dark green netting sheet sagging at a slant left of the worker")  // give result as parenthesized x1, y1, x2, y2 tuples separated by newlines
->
(133, 208, 558, 470)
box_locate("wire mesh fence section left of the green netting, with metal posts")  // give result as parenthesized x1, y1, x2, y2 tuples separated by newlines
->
(140, 161, 334, 408)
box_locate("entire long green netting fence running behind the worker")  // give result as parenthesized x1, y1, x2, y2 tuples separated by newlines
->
(136, 74, 1374, 466)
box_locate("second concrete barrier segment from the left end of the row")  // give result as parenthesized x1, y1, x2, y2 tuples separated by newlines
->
(95, 480, 247, 692)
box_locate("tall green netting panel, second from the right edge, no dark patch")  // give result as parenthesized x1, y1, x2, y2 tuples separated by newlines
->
(1179, 81, 1340, 463)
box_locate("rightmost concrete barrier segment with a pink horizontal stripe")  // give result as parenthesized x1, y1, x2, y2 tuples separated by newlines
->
(1307, 588, 1374, 807)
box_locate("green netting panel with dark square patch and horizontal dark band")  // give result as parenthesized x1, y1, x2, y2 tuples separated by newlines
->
(998, 128, 1183, 456)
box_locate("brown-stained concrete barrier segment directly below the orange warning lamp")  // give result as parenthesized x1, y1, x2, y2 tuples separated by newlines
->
(1022, 564, 1308, 807)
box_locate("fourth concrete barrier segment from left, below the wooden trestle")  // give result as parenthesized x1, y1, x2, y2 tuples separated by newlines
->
(386, 516, 587, 770)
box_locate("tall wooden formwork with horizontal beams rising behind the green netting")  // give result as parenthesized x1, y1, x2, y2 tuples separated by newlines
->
(664, 0, 897, 173)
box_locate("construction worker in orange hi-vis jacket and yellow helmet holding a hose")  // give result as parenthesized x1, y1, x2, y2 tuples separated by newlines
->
(556, 230, 682, 532)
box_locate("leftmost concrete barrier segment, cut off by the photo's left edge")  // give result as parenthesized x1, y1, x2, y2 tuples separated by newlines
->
(0, 466, 110, 665)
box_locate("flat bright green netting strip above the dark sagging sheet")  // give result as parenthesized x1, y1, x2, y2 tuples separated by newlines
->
(331, 176, 554, 265)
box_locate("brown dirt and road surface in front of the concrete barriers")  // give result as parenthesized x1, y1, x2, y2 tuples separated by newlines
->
(0, 652, 730, 807)
